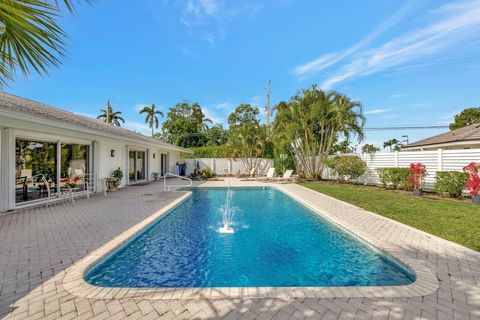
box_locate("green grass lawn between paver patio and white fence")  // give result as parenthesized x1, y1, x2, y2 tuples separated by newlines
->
(301, 182, 480, 251)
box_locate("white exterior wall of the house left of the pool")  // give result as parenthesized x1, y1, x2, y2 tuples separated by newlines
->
(0, 115, 180, 211)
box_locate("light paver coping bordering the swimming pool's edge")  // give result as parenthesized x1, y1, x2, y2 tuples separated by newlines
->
(62, 183, 440, 300)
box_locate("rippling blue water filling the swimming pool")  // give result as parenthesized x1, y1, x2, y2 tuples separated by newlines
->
(85, 188, 415, 288)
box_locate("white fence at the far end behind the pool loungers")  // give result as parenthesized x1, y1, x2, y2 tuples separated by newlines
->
(182, 158, 273, 176)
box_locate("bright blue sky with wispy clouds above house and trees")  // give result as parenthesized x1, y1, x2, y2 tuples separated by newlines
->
(5, 0, 480, 149)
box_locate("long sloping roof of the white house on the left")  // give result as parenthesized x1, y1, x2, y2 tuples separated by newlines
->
(0, 92, 192, 153)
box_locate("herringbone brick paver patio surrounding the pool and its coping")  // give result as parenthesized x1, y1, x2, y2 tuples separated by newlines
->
(0, 180, 480, 319)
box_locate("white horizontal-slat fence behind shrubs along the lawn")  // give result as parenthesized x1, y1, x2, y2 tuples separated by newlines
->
(323, 149, 480, 190)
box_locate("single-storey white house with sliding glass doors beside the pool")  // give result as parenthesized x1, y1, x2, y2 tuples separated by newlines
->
(0, 93, 190, 211)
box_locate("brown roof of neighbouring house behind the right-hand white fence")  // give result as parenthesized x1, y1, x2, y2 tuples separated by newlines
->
(404, 123, 480, 148)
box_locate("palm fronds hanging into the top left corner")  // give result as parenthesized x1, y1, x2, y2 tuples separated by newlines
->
(0, 0, 91, 86)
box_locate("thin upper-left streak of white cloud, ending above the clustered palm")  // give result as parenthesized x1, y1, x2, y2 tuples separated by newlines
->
(293, 2, 412, 78)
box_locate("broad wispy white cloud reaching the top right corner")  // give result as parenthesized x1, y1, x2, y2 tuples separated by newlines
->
(321, 0, 480, 89)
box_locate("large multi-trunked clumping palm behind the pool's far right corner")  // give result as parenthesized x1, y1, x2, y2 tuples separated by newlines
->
(273, 86, 365, 179)
